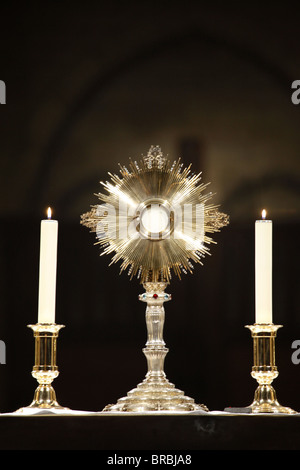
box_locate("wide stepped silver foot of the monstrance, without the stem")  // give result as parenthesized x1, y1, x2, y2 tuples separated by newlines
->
(103, 376, 208, 413)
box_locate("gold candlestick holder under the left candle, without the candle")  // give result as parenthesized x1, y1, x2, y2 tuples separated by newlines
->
(17, 323, 69, 413)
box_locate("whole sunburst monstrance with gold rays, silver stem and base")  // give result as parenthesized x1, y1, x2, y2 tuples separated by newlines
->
(81, 146, 229, 412)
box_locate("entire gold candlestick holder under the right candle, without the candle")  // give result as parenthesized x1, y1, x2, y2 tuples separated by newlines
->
(246, 323, 296, 414)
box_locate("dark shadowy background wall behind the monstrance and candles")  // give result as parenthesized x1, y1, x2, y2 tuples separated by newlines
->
(0, 1, 300, 412)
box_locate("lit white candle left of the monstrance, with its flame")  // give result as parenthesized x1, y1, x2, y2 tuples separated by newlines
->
(38, 207, 58, 323)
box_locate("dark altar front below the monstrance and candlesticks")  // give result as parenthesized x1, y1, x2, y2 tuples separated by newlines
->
(0, 413, 300, 451)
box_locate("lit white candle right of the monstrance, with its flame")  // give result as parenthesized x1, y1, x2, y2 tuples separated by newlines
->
(255, 210, 273, 323)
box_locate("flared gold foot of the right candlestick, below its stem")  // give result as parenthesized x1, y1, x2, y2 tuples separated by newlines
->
(249, 385, 296, 414)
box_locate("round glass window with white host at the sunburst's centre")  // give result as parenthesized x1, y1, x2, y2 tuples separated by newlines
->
(140, 201, 170, 240)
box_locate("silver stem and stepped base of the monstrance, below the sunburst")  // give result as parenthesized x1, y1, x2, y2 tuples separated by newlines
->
(103, 282, 208, 412)
